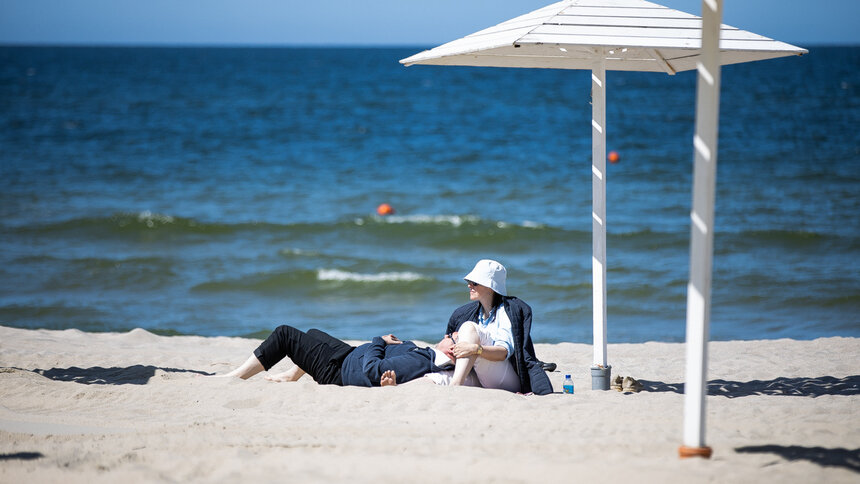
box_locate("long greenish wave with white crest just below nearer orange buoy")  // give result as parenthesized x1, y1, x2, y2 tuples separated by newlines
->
(13, 210, 844, 257)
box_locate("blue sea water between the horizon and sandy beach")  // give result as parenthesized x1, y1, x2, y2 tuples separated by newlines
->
(0, 47, 860, 342)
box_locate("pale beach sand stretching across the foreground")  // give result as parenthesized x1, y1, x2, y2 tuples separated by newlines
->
(0, 327, 860, 484)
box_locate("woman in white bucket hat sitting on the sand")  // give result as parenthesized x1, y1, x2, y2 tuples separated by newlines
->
(440, 259, 552, 395)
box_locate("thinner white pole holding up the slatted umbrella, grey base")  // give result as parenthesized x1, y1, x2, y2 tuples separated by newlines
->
(591, 55, 610, 390)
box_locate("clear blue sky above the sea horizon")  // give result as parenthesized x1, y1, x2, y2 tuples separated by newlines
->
(0, 0, 860, 47)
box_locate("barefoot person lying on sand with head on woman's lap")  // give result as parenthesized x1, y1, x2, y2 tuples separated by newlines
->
(212, 325, 454, 387)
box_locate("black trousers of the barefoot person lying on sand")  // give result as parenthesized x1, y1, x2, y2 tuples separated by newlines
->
(254, 325, 355, 385)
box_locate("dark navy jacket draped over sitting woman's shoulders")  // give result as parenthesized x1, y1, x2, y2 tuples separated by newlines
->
(445, 296, 552, 395)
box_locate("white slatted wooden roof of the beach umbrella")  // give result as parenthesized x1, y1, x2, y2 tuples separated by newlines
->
(400, 0, 807, 74)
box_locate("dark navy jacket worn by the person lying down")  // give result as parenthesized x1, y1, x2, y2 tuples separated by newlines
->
(341, 336, 440, 387)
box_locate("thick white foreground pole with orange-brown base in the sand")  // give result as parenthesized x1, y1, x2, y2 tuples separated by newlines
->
(679, 0, 723, 458)
